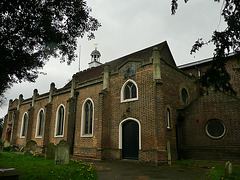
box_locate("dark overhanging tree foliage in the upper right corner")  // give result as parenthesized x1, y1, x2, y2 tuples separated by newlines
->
(171, 0, 240, 94)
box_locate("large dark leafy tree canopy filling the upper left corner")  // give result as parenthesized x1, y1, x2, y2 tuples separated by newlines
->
(0, 0, 101, 100)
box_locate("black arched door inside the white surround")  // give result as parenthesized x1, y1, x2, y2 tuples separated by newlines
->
(122, 120, 139, 159)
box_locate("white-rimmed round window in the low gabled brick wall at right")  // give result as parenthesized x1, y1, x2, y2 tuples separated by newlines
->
(206, 119, 226, 139)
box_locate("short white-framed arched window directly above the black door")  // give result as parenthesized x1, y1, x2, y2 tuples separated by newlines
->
(121, 79, 138, 102)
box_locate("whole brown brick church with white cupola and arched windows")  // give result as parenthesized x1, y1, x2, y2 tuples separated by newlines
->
(2, 42, 240, 164)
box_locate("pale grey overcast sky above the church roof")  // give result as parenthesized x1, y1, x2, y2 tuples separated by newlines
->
(0, 0, 224, 117)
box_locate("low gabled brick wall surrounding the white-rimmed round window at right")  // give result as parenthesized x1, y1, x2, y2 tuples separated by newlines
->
(182, 91, 240, 161)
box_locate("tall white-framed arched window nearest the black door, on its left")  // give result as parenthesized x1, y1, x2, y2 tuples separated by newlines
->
(81, 98, 94, 137)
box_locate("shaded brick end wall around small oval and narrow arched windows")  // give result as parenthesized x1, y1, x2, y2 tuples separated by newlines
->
(157, 61, 199, 161)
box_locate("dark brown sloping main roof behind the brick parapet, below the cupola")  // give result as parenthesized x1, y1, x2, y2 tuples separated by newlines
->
(64, 41, 176, 87)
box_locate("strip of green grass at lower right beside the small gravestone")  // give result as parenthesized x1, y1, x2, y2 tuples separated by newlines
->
(177, 160, 240, 180)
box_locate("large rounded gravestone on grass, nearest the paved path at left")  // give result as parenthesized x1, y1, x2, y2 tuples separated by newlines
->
(55, 140, 69, 165)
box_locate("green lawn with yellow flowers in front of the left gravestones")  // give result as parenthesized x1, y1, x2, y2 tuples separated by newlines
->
(0, 152, 97, 180)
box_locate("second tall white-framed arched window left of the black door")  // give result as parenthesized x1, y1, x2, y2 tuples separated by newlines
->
(55, 105, 65, 137)
